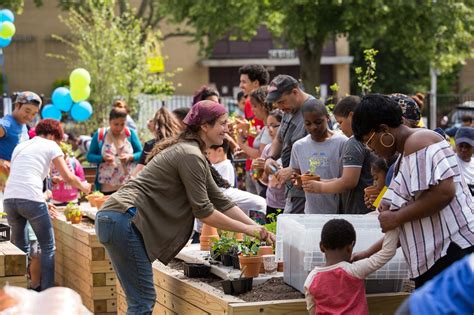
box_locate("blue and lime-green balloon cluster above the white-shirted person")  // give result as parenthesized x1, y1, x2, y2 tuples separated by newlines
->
(41, 68, 92, 122)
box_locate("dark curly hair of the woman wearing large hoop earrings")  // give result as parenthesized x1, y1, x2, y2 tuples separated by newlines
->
(352, 94, 403, 141)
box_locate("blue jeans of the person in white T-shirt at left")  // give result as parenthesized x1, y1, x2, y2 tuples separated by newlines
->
(3, 199, 55, 290)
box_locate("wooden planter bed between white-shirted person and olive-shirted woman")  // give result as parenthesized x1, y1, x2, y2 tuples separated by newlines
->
(53, 209, 117, 314)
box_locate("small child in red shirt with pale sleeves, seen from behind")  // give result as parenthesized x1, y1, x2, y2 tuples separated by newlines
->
(304, 219, 398, 315)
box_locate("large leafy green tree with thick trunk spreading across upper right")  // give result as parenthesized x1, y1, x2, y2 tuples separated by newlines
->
(156, 0, 474, 93)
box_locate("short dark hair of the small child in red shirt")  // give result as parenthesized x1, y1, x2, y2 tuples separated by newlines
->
(321, 219, 356, 249)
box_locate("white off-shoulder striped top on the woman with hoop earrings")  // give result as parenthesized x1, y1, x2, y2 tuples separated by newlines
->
(382, 140, 474, 278)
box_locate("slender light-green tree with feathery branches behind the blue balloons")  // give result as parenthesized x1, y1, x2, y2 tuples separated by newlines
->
(53, 0, 176, 131)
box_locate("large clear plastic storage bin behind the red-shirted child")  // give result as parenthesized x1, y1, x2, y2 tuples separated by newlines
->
(276, 214, 408, 293)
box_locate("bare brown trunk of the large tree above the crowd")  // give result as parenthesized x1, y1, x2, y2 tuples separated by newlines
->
(297, 39, 324, 95)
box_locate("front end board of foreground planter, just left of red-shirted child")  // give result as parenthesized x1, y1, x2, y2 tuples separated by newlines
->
(229, 299, 308, 315)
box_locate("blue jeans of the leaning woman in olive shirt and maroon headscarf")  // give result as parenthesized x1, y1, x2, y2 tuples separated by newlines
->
(95, 211, 156, 314)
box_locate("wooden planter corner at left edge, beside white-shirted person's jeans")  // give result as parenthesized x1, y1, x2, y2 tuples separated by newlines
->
(0, 241, 27, 288)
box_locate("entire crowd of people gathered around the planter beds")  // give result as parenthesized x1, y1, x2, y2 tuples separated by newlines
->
(0, 65, 474, 313)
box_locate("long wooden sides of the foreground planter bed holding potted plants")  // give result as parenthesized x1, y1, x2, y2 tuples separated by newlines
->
(117, 262, 408, 315)
